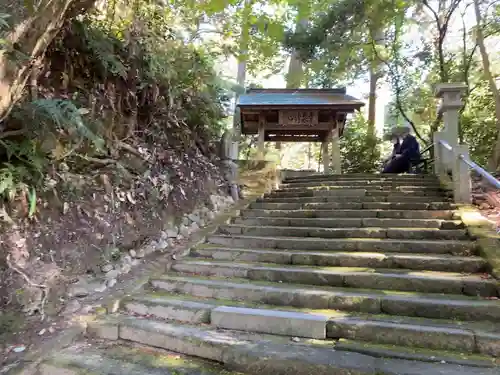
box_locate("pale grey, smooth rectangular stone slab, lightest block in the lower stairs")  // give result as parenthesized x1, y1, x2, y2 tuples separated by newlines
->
(211, 306, 328, 339)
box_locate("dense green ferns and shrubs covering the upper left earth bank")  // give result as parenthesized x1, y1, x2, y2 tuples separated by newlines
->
(0, 5, 234, 212)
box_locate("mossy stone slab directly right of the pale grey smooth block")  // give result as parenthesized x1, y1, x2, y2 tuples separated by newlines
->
(327, 318, 475, 353)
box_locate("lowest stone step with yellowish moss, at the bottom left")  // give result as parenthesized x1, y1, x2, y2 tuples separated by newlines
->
(37, 343, 233, 375)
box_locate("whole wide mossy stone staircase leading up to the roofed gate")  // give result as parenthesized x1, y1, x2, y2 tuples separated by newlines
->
(42, 175, 500, 375)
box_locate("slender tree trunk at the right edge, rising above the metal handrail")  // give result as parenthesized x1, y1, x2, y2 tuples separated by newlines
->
(474, 0, 500, 171)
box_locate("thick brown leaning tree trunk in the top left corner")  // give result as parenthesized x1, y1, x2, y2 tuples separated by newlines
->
(0, 0, 95, 121)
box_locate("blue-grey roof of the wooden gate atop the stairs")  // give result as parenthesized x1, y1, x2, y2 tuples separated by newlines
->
(238, 88, 364, 107)
